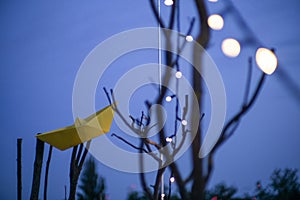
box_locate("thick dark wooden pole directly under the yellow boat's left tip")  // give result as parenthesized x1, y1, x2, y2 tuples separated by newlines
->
(30, 136, 44, 200)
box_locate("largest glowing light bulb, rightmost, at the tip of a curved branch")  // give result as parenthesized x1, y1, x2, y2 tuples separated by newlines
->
(255, 48, 278, 75)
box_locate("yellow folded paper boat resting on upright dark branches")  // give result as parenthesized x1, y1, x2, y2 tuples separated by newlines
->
(36, 106, 114, 150)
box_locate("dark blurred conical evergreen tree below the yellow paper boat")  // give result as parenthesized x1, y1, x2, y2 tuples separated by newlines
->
(77, 157, 105, 200)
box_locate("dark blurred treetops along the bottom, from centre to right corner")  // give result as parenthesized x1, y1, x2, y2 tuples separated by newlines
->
(127, 169, 300, 200)
